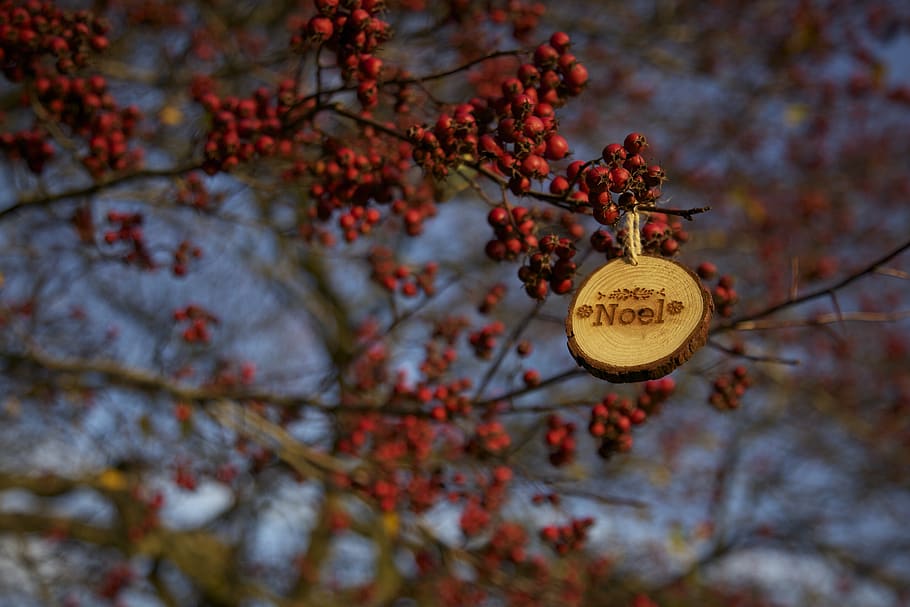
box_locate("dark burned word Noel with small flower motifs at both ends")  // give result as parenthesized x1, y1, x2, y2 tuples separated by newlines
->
(575, 287, 684, 327)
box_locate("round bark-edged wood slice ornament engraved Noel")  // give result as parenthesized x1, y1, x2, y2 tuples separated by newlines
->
(566, 255, 714, 382)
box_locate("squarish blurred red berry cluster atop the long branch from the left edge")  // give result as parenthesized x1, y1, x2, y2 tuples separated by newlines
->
(193, 81, 294, 175)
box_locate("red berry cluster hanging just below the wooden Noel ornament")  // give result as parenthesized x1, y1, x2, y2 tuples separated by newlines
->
(588, 377, 676, 458)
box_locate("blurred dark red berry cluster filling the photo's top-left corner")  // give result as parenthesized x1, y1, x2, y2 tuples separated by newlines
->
(0, 0, 109, 82)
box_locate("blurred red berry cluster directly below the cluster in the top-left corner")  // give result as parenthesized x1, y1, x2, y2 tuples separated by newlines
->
(34, 74, 143, 177)
